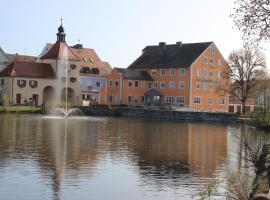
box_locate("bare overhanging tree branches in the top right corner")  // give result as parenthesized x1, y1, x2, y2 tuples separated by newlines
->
(231, 0, 270, 42)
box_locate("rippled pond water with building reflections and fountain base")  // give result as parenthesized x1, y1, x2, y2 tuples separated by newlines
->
(0, 114, 266, 200)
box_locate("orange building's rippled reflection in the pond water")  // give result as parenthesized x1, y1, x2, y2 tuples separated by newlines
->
(101, 120, 227, 178)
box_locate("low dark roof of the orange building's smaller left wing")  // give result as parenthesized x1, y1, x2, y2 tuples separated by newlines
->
(114, 68, 153, 81)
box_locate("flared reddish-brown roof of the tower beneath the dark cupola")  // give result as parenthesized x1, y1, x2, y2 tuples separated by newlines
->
(40, 41, 81, 60)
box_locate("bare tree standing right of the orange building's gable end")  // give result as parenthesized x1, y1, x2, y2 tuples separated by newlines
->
(227, 44, 266, 113)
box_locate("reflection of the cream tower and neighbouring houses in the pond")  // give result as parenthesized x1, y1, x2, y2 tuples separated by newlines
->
(0, 115, 97, 199)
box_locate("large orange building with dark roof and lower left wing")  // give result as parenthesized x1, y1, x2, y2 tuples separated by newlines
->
(104, 42, 229, 112)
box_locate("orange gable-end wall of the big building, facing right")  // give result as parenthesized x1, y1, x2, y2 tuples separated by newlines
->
(191, 44, 229, 112)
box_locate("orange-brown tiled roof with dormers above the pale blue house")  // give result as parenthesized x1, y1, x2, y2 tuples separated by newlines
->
(44, 43, 112, 76)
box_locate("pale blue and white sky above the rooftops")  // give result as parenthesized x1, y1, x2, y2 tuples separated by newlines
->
(0, 0, 270, 68)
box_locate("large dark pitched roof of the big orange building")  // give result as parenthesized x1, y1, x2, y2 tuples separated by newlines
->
(128, 42, 212, 69)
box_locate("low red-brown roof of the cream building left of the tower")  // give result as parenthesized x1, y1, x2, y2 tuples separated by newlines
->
(0, 61, 56, 78)
